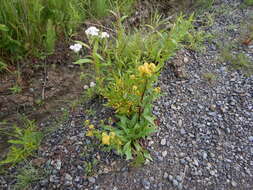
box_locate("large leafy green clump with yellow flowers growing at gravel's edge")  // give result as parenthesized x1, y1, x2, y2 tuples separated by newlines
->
(80, 13, 193, 165)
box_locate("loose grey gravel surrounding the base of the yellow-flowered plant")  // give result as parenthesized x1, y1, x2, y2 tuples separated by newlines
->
(0, 0, 253, 190)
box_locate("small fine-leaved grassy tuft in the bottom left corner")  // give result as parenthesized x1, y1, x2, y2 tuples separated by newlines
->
(14, 163, 47, 190)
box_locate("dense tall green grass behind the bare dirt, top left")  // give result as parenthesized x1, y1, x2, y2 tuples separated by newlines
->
(0, 0, 85, 58)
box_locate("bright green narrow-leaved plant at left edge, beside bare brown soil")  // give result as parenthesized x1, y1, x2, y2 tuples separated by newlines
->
(0, 119, 42, 165)
